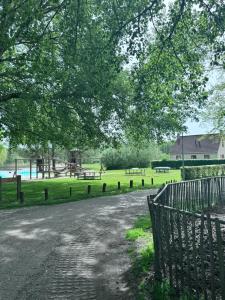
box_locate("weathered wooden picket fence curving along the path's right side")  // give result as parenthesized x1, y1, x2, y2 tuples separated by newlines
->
(148, 177, 225, 300)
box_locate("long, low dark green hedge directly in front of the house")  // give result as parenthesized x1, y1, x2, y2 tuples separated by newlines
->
(151, 159, 225, 169)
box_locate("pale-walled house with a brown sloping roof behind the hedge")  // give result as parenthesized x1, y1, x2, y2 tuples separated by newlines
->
(170, 134, 225, 160)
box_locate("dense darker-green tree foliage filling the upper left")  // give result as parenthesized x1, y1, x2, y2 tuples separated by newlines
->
(0, 0, 165, 146)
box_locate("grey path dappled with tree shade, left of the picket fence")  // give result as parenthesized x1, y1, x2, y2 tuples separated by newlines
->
(0, 191, 154, 300)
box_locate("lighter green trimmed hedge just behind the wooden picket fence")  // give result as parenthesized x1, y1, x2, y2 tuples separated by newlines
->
(181, 165, 225, 180)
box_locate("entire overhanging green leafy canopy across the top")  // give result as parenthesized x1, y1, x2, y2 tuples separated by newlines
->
(0, 0, 225, 147)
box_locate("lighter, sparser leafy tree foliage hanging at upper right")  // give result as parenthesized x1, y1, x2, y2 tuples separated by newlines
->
(125, 1, 225, 140)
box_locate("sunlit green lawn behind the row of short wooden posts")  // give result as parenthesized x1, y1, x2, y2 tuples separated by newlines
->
(0, 164, 180, 208)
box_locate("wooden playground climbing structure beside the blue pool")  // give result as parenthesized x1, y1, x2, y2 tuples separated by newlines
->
(13, 150, 84, 179)
